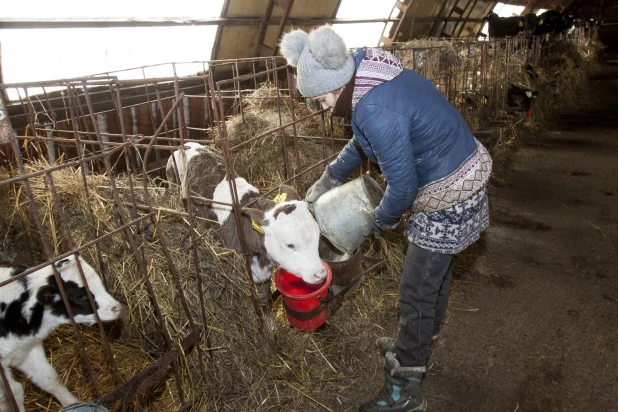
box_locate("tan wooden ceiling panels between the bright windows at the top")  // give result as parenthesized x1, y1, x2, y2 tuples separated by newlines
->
(212, 0, 603, 59)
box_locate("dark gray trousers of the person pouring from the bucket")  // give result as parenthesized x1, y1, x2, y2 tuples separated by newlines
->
(395, 242, 454, 366)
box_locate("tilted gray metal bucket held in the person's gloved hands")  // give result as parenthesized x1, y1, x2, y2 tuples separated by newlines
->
(313, 175, 384, 255)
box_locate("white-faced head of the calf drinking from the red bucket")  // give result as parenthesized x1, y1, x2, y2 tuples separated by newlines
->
(243, 192, 326, 284)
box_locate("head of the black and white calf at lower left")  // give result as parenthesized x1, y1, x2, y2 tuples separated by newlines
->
(36, 255, 121, 325)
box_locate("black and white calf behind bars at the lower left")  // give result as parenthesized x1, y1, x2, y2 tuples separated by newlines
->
(0, 255, 121, 411)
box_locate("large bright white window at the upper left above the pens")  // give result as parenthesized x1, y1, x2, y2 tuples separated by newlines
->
(0, 0, 223, 100)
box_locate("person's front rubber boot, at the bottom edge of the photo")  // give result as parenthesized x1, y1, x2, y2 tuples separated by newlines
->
(358, 352, 427, 412)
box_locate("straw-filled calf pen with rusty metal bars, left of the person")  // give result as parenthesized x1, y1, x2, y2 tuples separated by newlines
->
(0, 58, 358, 410)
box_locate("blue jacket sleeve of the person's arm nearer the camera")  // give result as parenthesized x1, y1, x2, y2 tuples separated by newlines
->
(356, 104, 418, 228)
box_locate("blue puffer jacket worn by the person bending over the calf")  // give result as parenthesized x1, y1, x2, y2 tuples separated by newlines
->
(328, 50, 476, 226)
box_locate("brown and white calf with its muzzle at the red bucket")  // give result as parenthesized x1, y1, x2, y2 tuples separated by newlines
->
(166, 143, 326, 292)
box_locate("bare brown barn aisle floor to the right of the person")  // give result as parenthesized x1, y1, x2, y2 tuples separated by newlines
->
(424, 57, 618, 412)
